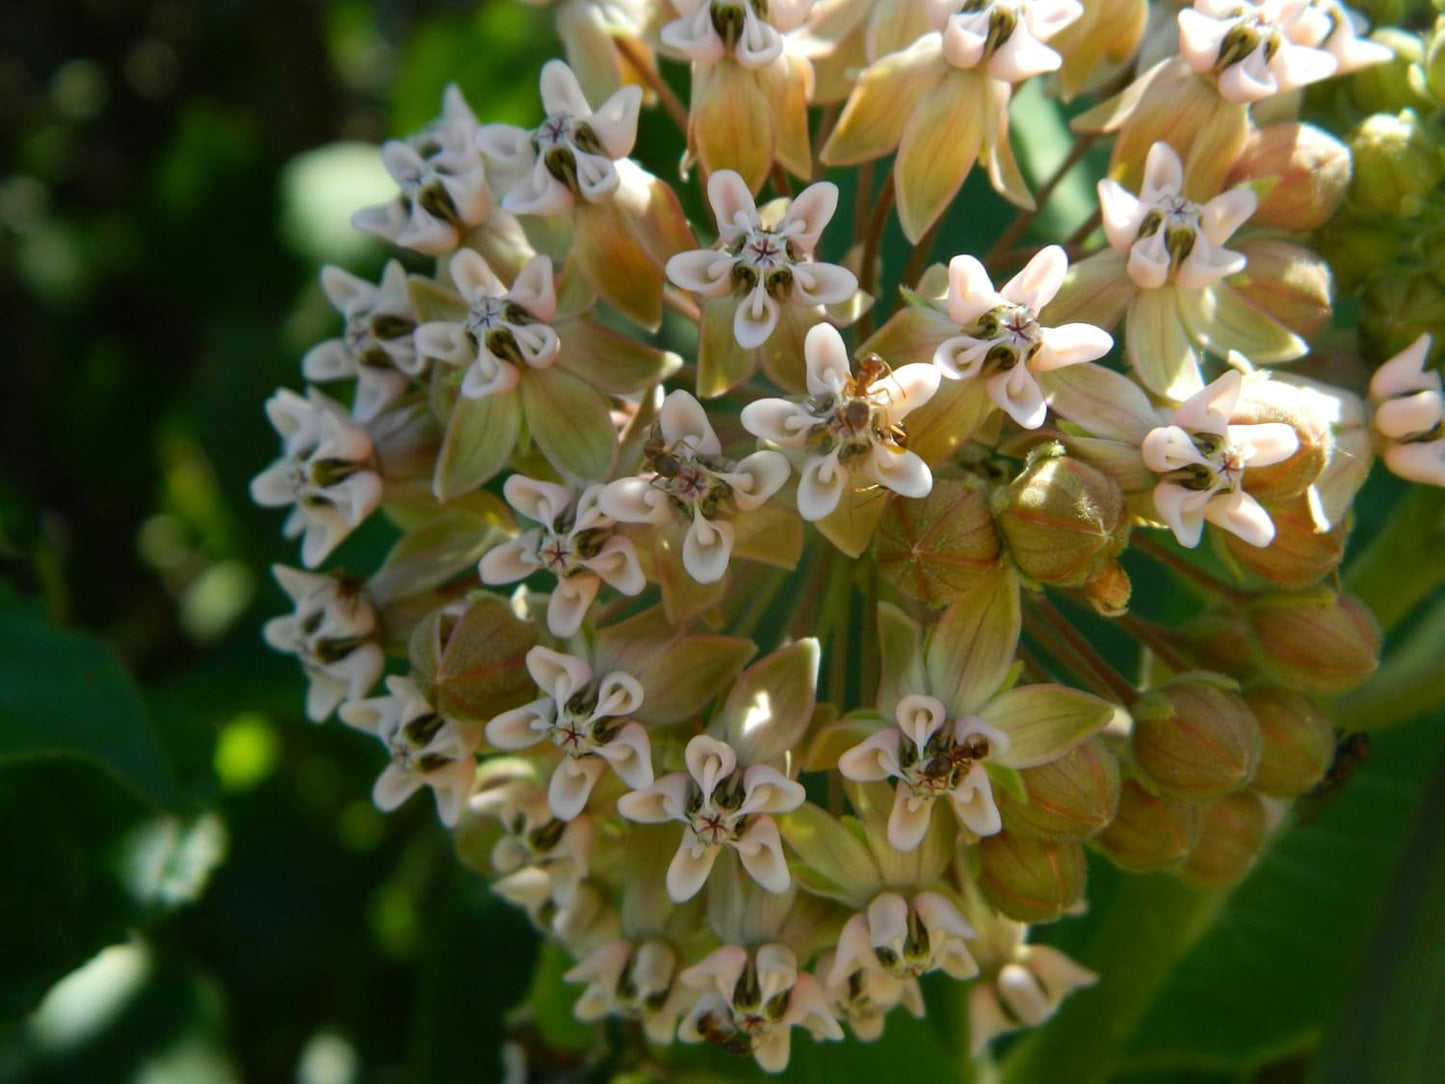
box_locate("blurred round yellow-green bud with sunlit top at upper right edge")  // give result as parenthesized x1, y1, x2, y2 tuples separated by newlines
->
(1350, 110, 1445, 218)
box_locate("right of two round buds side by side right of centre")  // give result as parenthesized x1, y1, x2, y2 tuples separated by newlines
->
(996, 444, 1130, 587)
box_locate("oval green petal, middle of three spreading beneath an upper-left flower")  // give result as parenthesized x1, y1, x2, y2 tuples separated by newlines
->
(520, 366, 617, 483)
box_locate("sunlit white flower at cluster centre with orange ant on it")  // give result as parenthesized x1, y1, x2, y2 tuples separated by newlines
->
(743, 324, 941, 520)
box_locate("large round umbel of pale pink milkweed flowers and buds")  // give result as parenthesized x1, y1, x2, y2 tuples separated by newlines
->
(251, 0, 1445, 1072)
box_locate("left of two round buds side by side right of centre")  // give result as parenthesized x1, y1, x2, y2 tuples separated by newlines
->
(873, 478, 1000, 606)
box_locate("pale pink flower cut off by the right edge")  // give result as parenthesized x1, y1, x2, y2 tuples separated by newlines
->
(1370, 334, 1445, 486)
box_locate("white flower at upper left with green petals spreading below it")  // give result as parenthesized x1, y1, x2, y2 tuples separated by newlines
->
(416, 249, 562, 399)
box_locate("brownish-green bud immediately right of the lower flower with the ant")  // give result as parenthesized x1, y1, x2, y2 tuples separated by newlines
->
(996, 736, 1118, 840)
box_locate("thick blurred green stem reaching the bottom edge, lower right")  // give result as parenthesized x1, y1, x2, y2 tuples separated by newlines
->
(1000, 873, 1224, 1084)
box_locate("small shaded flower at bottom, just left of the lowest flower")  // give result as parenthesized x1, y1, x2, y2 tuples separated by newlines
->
(562, 938, 696, 1044)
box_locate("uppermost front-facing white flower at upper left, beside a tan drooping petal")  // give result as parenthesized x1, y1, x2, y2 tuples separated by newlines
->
(477, 61, 642, 215)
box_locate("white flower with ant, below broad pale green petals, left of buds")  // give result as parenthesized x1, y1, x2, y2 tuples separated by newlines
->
(838, 692, 1010, 851)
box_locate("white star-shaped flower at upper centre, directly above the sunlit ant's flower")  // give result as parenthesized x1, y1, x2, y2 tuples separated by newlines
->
(666, 169, 858, 350)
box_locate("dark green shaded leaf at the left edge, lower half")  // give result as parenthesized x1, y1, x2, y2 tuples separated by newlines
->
(0, 613, 178, 808)
